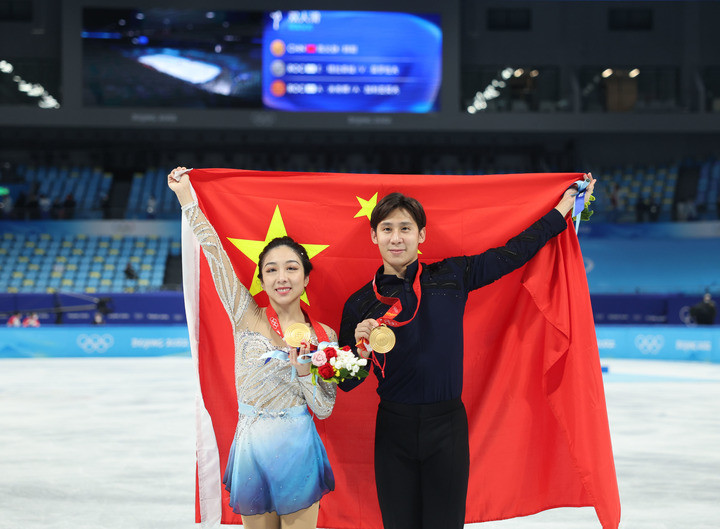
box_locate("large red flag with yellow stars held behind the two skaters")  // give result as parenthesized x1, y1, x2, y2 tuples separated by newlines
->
(183, 169, 620, 529)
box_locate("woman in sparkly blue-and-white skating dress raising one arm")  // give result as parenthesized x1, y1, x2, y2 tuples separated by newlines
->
(168, 167, 337, 529)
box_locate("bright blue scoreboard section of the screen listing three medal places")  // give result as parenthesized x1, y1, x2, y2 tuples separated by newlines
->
(262, 11, 442, 113)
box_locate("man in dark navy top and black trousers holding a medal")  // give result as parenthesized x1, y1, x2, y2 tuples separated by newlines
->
(339, 179, 595, 529)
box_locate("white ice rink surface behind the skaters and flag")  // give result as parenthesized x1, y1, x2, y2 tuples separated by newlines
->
(0, 357, 720, 529)
